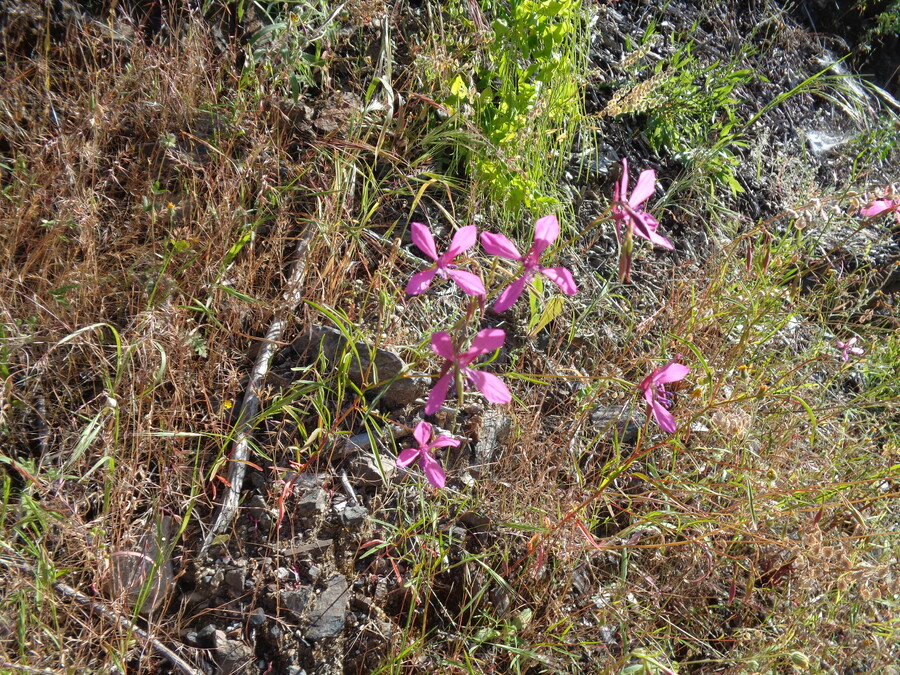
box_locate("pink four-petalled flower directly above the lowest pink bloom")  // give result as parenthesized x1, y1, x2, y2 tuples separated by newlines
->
(425, 328, 512, 415)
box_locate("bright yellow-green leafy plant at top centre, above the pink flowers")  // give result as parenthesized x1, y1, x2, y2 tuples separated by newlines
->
(445, 0, 583, 210)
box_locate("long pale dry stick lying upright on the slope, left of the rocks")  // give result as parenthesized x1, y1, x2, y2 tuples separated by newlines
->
(199, 224, 315, 557)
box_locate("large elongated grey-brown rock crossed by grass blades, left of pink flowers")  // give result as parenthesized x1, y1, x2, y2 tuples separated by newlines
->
(291, 324, 421, 408)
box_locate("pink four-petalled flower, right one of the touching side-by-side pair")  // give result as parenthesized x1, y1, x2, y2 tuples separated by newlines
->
(481, 215, 578, 312)
